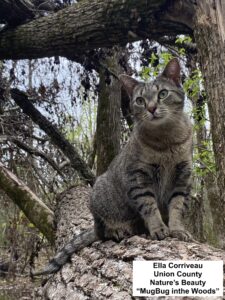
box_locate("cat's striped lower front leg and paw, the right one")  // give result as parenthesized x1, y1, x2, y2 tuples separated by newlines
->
(169, 195, 193, 241)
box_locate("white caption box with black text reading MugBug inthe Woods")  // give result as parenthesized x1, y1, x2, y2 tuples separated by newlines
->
(133, 260, 223, 297)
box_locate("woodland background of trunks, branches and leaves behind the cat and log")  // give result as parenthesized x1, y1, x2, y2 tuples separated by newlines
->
(0, 0, 225, 299)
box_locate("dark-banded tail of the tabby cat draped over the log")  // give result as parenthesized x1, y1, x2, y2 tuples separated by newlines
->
(31, 228, 99, 276)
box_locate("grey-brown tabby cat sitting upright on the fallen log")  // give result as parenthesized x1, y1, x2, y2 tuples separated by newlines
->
(34, 58, 192, 275)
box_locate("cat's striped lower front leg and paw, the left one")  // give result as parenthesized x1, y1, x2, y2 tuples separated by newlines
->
(130, 192, 169, 240)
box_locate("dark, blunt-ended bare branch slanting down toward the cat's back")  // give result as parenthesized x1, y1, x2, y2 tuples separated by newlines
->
(11, 89, 95, 185)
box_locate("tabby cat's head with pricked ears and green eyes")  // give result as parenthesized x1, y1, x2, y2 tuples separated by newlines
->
(119, 58, 184, 125)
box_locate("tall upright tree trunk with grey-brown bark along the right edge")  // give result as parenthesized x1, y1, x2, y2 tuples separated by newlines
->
(194, 0, 225, 247)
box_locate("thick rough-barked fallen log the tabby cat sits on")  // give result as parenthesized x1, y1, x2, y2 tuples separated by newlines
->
(34, 187, 225, 300)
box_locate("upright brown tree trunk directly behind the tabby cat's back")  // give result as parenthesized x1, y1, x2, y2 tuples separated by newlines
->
(97, 49, 122, 175)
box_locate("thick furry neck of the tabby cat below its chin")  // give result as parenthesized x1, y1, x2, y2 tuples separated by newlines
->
(133, 114, 192, 150)
